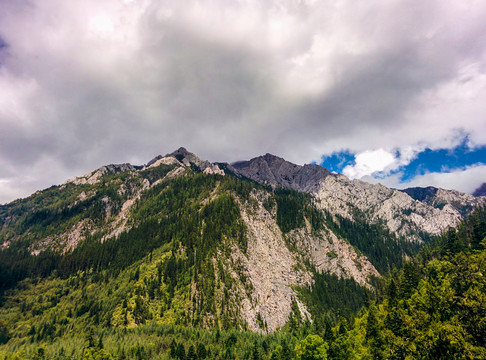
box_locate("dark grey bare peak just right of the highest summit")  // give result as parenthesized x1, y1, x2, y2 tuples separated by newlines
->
(231, 154, 330, 192)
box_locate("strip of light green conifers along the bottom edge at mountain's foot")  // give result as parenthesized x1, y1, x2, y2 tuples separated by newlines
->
(0, 325, 308, 360)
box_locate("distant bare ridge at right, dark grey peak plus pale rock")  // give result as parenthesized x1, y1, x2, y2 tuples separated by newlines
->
(232, 154, 484, 243)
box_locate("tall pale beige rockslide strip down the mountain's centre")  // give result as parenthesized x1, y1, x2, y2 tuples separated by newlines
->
(236, 194, 312, 332)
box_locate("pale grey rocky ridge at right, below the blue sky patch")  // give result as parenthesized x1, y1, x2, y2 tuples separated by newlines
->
(315, 175, 484, 242)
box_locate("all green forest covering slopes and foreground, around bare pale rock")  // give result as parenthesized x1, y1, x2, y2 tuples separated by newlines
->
(0, 165, 486, 360)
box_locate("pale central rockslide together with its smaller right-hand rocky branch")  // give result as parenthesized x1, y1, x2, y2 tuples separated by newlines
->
(233, 191, 379, 332)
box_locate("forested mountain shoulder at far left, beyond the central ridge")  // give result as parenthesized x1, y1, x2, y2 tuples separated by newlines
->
(0, 172, 148, 292)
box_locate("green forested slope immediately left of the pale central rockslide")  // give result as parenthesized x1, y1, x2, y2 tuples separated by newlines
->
(0, 172, 262, 358)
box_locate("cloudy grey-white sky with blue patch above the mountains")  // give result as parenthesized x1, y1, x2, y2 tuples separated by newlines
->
(0, 0, 486, 203)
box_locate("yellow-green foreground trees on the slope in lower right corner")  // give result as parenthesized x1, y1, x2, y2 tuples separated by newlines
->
(329, 208, 486, 359)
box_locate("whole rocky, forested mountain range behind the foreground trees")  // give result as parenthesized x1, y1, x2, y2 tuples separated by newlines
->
(0, 148, 484, 354)
